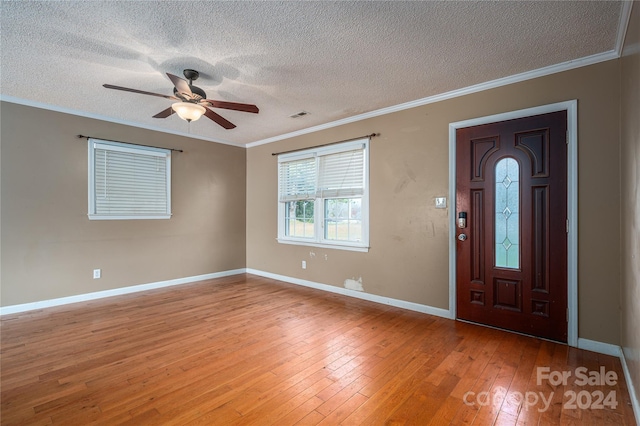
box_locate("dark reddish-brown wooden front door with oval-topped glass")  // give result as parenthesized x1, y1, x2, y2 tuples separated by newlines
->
(456, 111, 567, 342)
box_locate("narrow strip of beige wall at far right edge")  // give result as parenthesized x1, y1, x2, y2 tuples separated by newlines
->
(620, 2, 640, 416)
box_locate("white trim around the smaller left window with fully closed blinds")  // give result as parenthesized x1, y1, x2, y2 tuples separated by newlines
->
(87, 138, 172, 220)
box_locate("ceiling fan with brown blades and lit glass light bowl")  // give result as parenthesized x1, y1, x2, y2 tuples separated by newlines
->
(102, 69, 259, 129)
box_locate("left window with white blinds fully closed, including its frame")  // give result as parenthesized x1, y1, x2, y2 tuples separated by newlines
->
(89, 138, 171, 220)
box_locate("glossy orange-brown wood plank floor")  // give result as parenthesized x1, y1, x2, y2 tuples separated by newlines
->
(0, 275, 635, 425)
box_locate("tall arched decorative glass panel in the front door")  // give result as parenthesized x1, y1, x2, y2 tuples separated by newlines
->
(495, 157, 520, 269)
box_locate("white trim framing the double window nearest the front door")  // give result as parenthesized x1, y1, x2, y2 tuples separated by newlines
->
(276, 137, 370, 252)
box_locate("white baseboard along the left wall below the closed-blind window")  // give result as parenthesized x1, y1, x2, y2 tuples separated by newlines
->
(0, 268, 246, 316)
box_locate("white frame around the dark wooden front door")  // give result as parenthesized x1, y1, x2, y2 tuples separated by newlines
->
(449, 99, 578, 347)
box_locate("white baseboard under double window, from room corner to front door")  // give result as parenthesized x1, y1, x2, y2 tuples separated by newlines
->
(246, 268, 453, 319)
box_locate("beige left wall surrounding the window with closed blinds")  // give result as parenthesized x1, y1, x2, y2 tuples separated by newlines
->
(0, 102, 246, 306)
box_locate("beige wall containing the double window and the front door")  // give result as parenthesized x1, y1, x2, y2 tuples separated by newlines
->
(247, 61, 620, 344)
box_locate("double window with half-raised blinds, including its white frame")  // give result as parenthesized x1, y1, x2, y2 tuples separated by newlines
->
(278, 139, 369, 251)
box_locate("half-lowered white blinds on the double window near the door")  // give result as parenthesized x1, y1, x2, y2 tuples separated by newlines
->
(278, 142, 365, 202)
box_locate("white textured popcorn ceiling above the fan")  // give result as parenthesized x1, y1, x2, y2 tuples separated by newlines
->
(0, 0, 626, 145)
